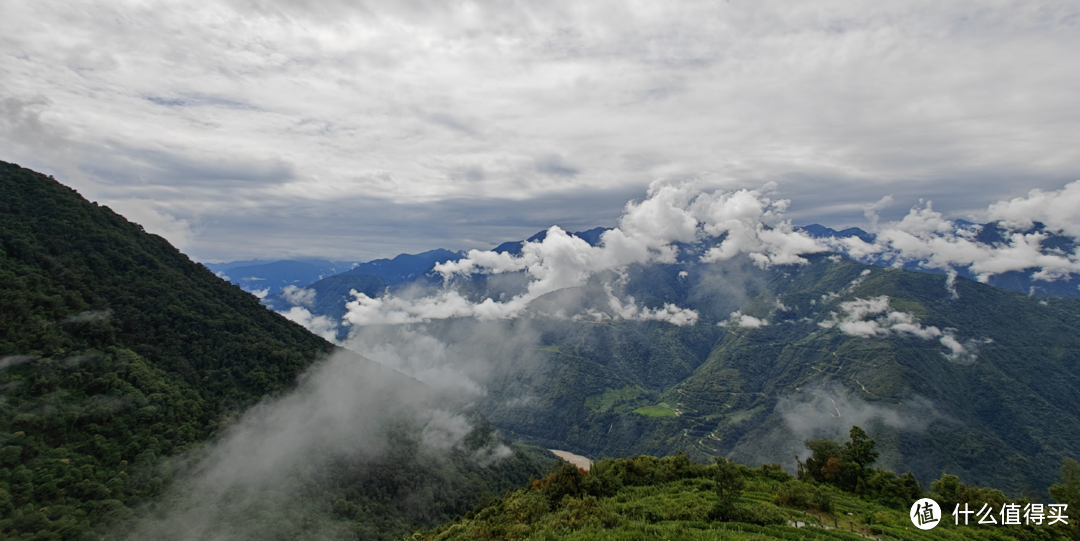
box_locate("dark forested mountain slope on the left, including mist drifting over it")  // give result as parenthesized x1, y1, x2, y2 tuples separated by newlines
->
(0, 162, 543, 539)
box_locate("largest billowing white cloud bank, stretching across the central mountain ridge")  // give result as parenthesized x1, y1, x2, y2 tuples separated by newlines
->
(345, 181, 824, 325)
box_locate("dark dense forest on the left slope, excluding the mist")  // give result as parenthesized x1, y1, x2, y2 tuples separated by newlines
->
(0, 162, 544, 540)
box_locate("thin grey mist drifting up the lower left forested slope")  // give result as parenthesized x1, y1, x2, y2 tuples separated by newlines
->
(126, 351, 513, 540)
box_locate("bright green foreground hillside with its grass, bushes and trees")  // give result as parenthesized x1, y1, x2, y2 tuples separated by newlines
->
(407, 442, 1080, 541)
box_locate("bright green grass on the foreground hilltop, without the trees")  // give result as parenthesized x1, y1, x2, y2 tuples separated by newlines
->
(407, 471, 1067, 541)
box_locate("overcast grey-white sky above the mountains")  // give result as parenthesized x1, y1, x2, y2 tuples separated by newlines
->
(0, 0, 1080, 261)
